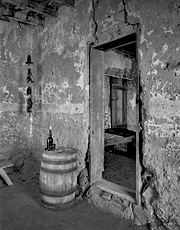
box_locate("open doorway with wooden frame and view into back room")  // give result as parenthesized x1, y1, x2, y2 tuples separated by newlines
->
(90, 28, 140, 203)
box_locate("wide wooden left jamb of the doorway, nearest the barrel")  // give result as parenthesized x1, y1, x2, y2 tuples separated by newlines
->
(90, 48, 105, 183)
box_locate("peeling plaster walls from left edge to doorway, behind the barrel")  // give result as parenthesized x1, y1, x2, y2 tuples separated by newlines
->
(0, 1, 92, 172)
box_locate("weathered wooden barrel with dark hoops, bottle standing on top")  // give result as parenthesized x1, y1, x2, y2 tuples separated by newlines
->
(39, 147, 77, 209)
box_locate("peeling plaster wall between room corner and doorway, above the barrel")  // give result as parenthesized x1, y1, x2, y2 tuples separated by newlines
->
(38, 1, 91, 169)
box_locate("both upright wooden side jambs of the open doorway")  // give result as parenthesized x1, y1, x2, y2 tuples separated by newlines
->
(90, 26, 141, 205)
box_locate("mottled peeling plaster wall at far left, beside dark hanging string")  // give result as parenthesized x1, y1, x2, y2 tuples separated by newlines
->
(0, 21, 39, 167)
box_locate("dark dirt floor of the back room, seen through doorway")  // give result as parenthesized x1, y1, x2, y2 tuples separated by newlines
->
(103, 149, 136, 190)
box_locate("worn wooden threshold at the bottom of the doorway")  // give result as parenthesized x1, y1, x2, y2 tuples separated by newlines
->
(92, 179, 136, 203)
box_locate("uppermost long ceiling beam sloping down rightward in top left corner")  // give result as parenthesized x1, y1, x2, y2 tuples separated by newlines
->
(3, 0, 57, 17)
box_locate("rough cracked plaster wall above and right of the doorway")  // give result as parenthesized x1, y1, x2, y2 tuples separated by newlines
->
(94, 0, 180, 229)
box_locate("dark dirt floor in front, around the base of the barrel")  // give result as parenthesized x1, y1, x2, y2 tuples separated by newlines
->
(0, 169, 147, 230)
